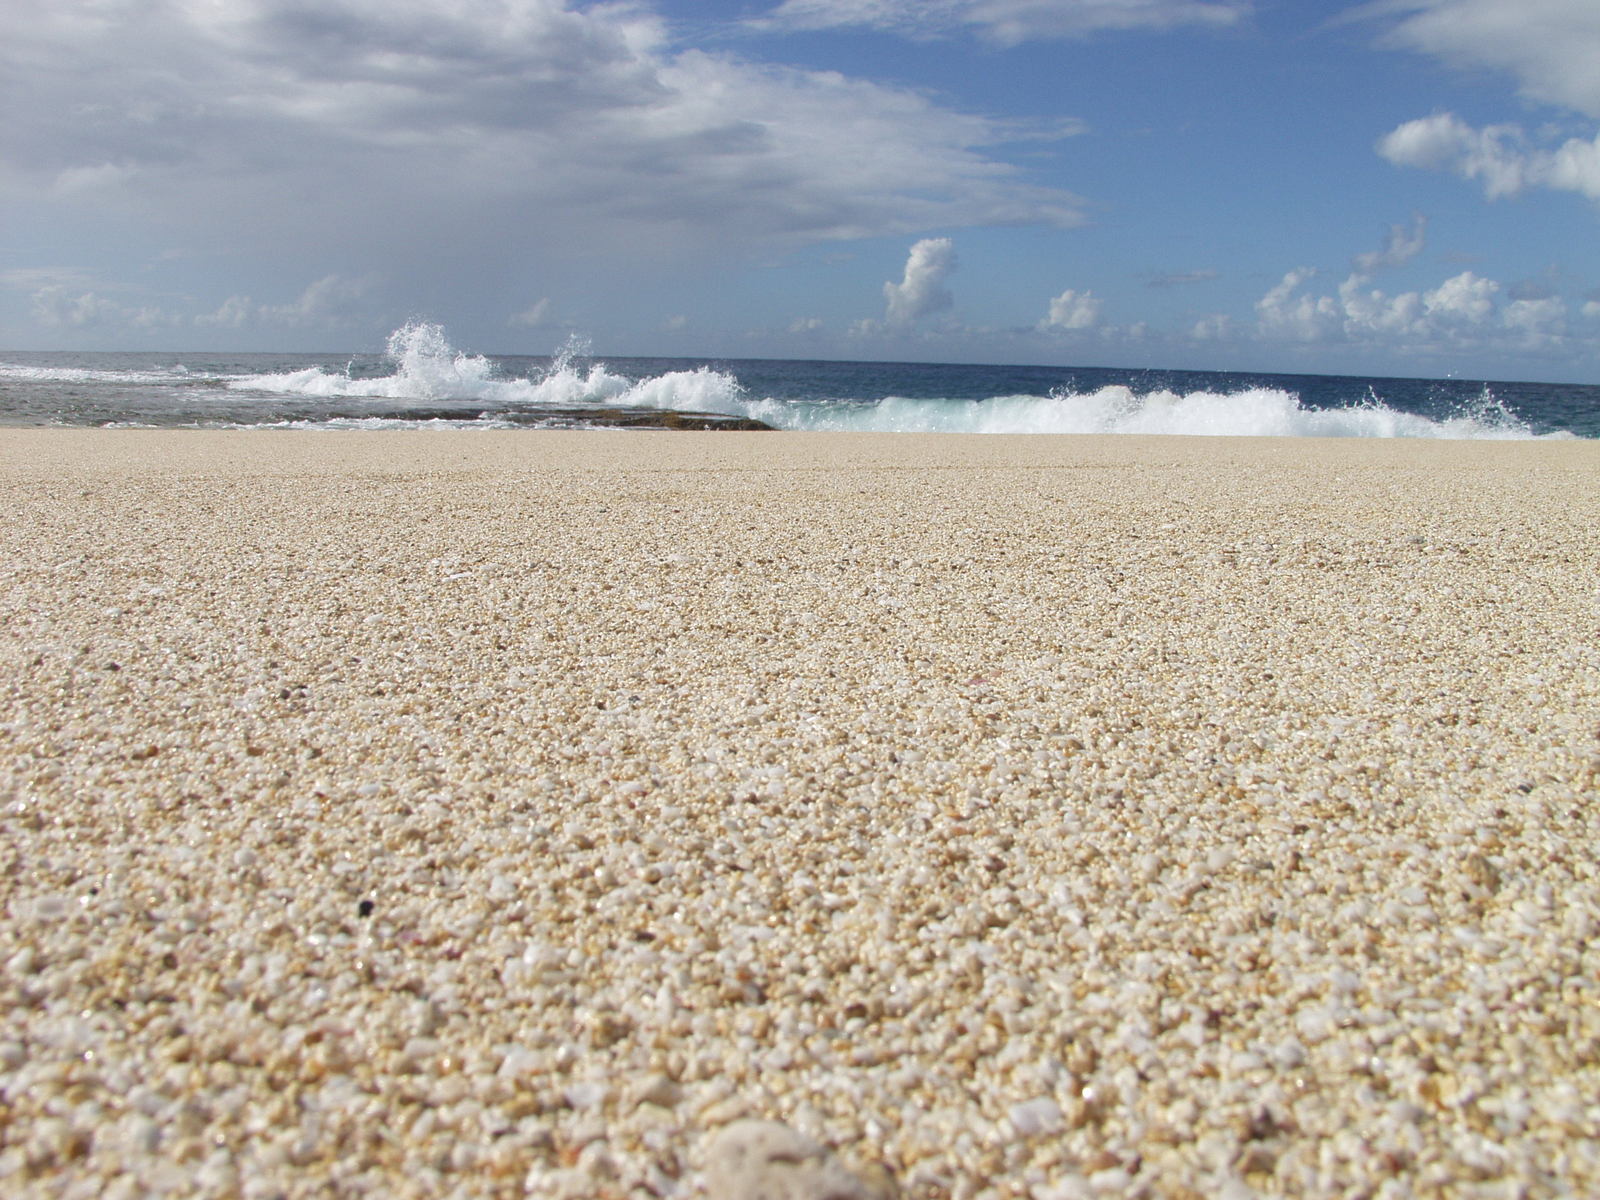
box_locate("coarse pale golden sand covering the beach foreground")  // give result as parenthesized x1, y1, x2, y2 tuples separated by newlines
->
(0, 430, 1600, 1200)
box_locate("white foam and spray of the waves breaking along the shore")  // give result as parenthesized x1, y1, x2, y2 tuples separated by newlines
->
(219, 323, 1555, 438)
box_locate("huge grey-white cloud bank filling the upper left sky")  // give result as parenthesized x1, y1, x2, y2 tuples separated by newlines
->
(0, 0, 1082, 266)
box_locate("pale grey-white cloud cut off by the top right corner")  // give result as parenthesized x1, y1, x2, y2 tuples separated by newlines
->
(1379, 0, 1600, 117)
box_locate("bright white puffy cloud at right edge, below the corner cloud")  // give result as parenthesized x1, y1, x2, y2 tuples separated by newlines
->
(1378, 112, 1600, 202)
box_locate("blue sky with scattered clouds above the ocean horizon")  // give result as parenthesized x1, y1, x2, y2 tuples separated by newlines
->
(0, 0, 1600, 382)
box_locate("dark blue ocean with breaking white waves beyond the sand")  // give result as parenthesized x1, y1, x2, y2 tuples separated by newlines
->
(0, 323, 1600, 438)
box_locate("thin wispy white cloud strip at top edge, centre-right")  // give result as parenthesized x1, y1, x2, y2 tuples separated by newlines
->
(752, 0, 1251, 45)
